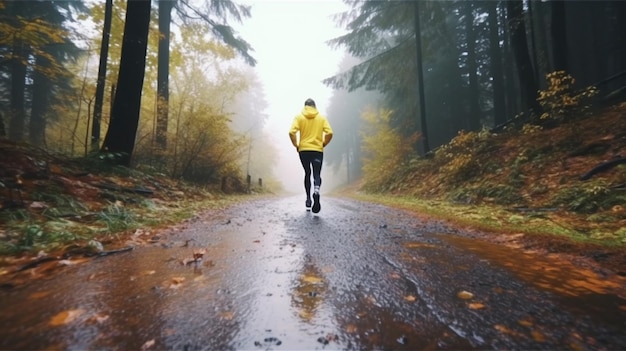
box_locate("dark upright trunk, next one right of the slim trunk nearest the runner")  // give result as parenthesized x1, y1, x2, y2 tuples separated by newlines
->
(465, 1, 480, 130)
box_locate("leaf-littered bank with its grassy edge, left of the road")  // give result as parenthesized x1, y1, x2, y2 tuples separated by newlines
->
(0, 143, 256, 258)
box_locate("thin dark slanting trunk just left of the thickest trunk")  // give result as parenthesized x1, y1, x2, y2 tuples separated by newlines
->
(91, 0, 113, 151)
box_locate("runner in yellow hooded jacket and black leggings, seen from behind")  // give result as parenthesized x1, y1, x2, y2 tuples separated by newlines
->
(289, 99, 333, 213)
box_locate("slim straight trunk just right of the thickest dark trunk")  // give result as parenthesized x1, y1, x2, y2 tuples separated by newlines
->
(156, 0, 174, 150)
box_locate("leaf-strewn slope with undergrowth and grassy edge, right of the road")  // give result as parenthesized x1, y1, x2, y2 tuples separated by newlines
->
(362, 72, 626, 245)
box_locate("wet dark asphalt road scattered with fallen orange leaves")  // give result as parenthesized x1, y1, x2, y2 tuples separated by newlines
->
(0, 197, 626, 350)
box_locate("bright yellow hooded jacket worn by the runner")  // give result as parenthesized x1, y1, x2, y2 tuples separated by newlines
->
(289, 106, 333, 152)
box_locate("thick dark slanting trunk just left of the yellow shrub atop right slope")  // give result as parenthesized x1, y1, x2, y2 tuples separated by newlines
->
(506, 0, 541, 117)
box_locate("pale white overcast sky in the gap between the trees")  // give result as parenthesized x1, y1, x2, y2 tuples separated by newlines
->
(239, 0, 346, 193)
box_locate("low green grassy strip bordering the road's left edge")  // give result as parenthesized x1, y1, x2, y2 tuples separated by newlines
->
(0, 193, 249, 256)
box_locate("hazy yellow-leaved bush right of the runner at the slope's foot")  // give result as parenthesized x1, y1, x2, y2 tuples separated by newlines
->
(361, 109, 418, 188)
